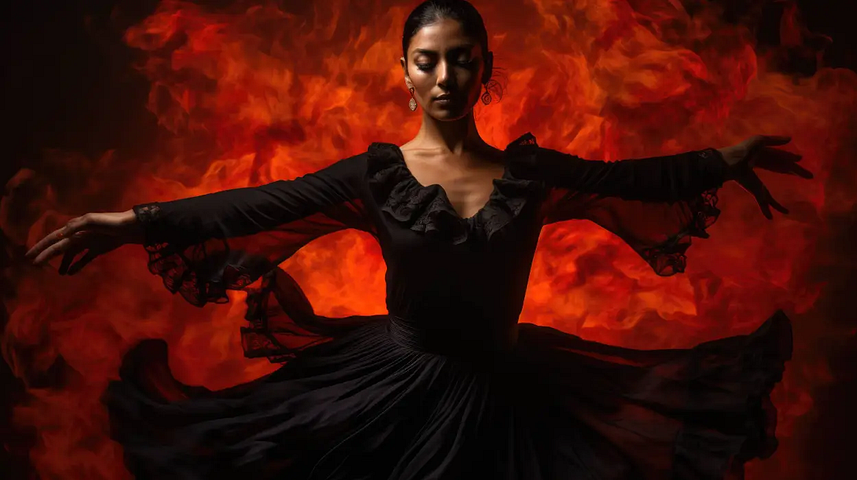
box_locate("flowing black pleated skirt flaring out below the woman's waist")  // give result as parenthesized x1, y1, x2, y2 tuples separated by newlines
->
(104, 294, 792, 480)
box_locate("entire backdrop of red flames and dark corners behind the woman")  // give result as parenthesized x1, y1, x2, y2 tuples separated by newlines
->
(0, 0, 857, 480)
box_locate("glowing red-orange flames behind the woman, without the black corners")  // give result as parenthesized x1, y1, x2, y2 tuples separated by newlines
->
(0, 0, 857, 480)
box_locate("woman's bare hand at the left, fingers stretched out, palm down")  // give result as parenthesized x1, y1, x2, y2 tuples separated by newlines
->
(26, 210, 143, 275)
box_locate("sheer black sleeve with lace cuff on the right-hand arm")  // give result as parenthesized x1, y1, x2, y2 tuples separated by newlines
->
(518, 144, 727, 275)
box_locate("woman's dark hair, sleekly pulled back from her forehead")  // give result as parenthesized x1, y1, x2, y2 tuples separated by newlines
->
(402, 0, 503, 98)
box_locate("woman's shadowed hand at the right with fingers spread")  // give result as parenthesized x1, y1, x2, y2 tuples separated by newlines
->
(717, 135, 812, 219)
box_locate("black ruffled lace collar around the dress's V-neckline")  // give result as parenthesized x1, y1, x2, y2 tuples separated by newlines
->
(367, 133, 541, 244)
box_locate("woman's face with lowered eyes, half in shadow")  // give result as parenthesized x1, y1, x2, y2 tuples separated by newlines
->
(401, 19, 491, 121)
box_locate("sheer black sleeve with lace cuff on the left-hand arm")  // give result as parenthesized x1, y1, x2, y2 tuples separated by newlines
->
(133, 156, 373, 306)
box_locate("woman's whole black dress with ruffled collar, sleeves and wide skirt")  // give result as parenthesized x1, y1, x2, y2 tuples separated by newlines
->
(104, 134, 792, 480)
